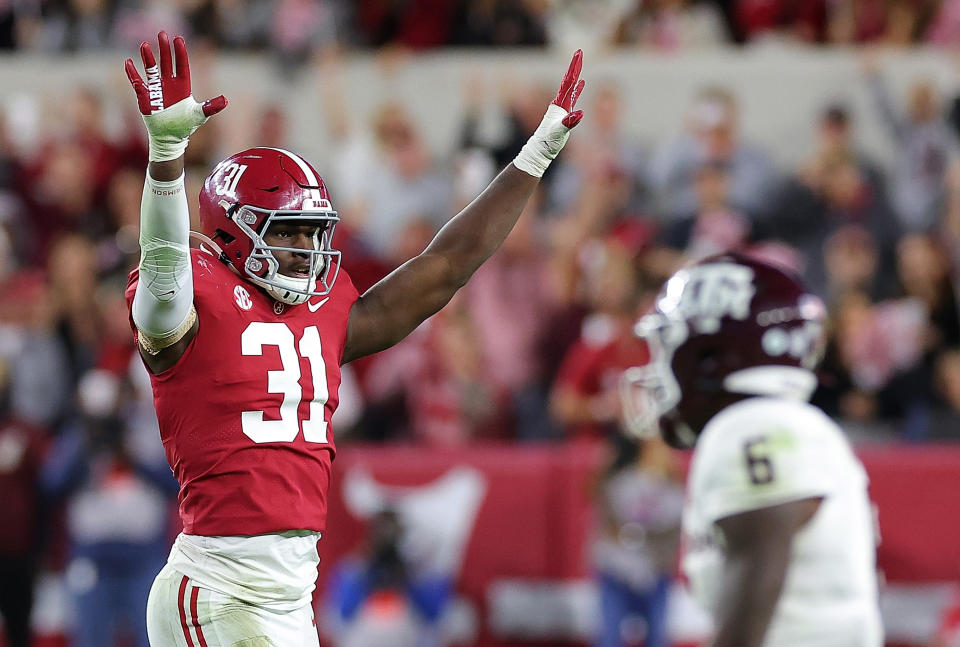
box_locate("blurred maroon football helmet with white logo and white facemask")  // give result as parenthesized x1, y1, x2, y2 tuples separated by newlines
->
(622, 253, 826, 449)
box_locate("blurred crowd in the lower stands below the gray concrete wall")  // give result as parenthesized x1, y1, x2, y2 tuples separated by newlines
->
(0, 44, 960, 445)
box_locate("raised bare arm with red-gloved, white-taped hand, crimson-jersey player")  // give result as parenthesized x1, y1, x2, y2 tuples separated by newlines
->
(342, 50, 584, 363)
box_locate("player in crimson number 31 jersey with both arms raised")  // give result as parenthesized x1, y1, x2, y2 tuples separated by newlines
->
(126, 32, 584, 647)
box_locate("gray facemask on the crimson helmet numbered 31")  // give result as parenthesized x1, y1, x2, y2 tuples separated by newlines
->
(231, 205, 340, 305)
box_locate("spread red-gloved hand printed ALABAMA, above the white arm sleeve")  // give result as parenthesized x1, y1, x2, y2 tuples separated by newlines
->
(124, 31, 227, 162)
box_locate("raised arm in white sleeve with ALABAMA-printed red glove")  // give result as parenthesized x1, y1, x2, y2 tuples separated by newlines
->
(124, 32, 227, 373)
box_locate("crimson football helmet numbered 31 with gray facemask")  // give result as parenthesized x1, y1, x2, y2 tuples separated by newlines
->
(200, 147, 340, 305)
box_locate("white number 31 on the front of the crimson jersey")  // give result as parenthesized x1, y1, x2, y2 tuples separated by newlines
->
(240, 321, 329, 443)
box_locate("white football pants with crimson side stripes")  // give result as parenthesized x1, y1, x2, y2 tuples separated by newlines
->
(147, 565, 320, 647)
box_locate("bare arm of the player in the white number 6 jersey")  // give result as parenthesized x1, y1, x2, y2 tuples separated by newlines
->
(711, 498, 821, 647)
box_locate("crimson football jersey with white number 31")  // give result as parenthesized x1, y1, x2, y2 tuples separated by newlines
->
(126, 250, 358, 536)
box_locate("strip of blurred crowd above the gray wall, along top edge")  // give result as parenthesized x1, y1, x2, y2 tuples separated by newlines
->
(7, 0, 960, 52)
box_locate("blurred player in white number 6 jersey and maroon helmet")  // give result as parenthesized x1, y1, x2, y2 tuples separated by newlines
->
(623, 254, 883, 647)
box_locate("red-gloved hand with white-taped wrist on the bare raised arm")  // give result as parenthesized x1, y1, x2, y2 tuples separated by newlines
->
(513, 49, 585, 177)
